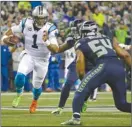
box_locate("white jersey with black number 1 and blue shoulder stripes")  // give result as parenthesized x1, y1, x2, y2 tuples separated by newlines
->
(11, 18, 58, 59)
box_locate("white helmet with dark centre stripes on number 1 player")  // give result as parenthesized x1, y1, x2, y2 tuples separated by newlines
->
(32, 6, 49, 28)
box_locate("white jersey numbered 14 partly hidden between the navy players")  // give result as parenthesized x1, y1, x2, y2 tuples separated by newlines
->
(64, 47, 76, 68)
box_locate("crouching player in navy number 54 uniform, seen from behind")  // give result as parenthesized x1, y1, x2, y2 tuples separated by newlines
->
(62, 21, 131, 125)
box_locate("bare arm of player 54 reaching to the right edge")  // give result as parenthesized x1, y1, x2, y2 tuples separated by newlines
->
(113, 38, 132, 67)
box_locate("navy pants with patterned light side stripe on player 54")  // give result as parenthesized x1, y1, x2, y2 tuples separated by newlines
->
(73, 58, 131, 117)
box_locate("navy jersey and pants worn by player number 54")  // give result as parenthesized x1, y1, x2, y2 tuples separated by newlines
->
(73, 22, 131, 119)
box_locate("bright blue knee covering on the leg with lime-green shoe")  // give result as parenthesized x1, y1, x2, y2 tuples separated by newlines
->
(14, 72, 26, 89)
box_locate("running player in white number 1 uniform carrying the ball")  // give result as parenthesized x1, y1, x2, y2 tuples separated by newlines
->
(2, 6, 59, 113)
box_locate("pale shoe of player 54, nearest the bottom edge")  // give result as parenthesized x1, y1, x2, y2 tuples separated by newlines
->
(61, 118, 81, 125)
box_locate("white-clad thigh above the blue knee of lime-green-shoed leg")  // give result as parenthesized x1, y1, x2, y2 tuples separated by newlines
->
(17, 54, 34, 75)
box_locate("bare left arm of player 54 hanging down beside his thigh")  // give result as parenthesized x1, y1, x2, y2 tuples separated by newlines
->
(76, 50, 85, 80)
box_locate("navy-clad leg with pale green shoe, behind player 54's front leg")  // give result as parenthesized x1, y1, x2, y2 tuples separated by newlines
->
(52, 67, 78, 114)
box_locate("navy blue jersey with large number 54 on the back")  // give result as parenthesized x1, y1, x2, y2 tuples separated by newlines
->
(75, 34, 117, 65)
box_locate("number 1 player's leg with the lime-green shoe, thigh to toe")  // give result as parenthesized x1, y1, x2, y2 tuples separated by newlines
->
(12, 54, 34, 107)
